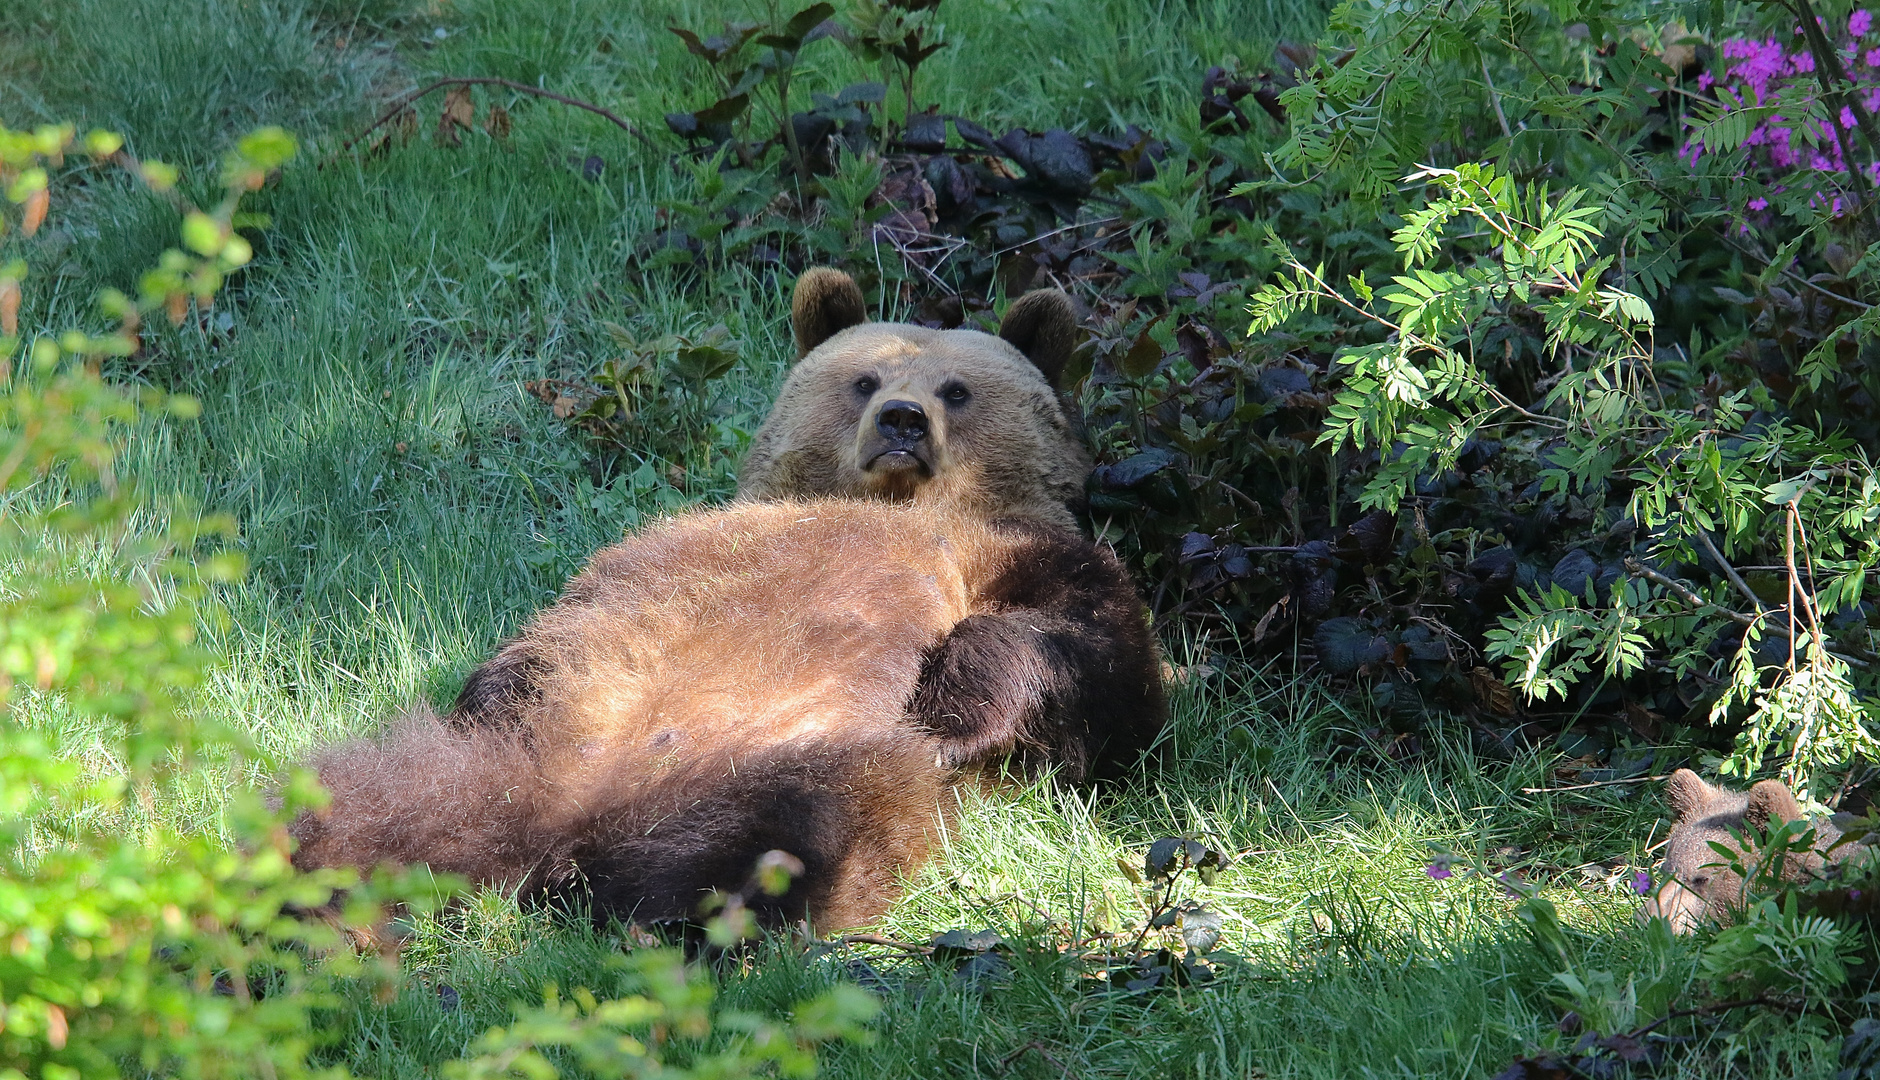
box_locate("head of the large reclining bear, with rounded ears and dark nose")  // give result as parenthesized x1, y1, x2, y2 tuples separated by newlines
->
(737, 269, 1090, 529)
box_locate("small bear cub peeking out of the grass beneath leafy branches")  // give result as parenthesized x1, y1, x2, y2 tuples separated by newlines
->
(1645, 770, 1841, 933)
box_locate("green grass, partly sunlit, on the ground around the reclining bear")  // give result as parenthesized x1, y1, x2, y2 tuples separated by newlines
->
(0, 0, 1833, 1078)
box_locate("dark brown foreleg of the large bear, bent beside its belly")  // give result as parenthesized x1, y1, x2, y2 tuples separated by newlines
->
(908, 525, 1164, 781)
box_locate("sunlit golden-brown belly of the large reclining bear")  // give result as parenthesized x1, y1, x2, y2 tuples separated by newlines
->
(517, 500, 993, 773)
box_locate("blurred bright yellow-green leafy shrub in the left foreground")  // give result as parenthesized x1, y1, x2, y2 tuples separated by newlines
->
(0, 120, 438, 1078)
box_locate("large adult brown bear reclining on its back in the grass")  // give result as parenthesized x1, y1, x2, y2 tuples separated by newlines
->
(293, 271, 1164, 929)
